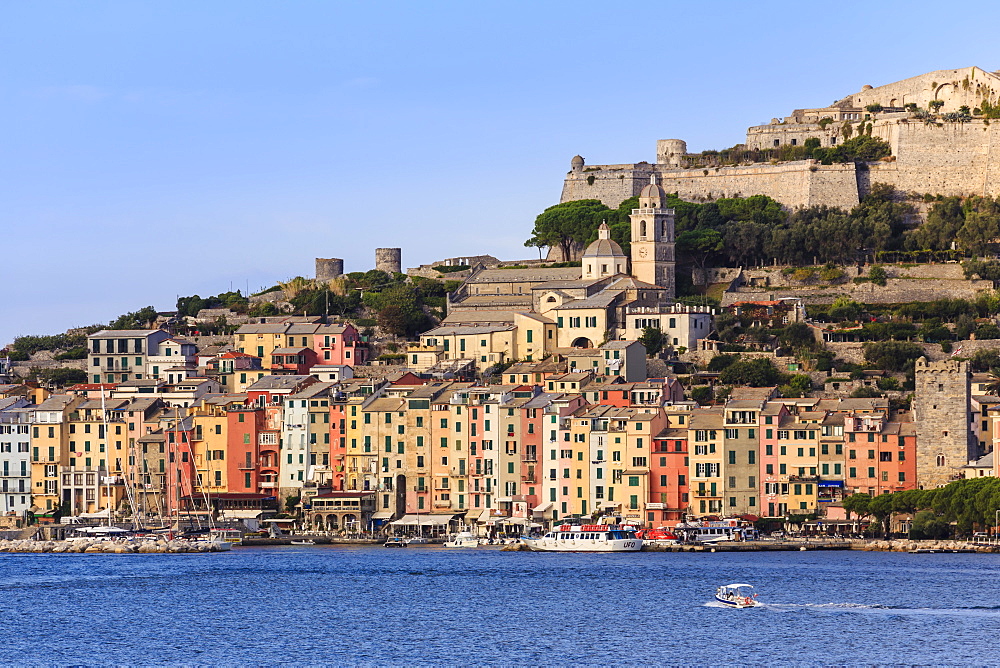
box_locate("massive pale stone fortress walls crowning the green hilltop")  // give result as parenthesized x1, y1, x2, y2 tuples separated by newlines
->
(560, 68, 1000, 208)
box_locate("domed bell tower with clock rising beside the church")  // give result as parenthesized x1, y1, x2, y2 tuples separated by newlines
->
(630, 174, 676, 300)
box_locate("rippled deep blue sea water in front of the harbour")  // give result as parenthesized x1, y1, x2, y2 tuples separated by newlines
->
(0, 546, 1000, 665)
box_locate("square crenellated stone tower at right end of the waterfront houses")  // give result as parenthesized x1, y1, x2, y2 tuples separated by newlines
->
(913, 357, 977, 489)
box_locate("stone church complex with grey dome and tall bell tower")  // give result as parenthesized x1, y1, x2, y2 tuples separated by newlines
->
(421, 177, 712, 364)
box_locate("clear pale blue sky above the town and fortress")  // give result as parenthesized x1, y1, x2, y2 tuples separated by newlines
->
(0, 0, 1000, 345)
